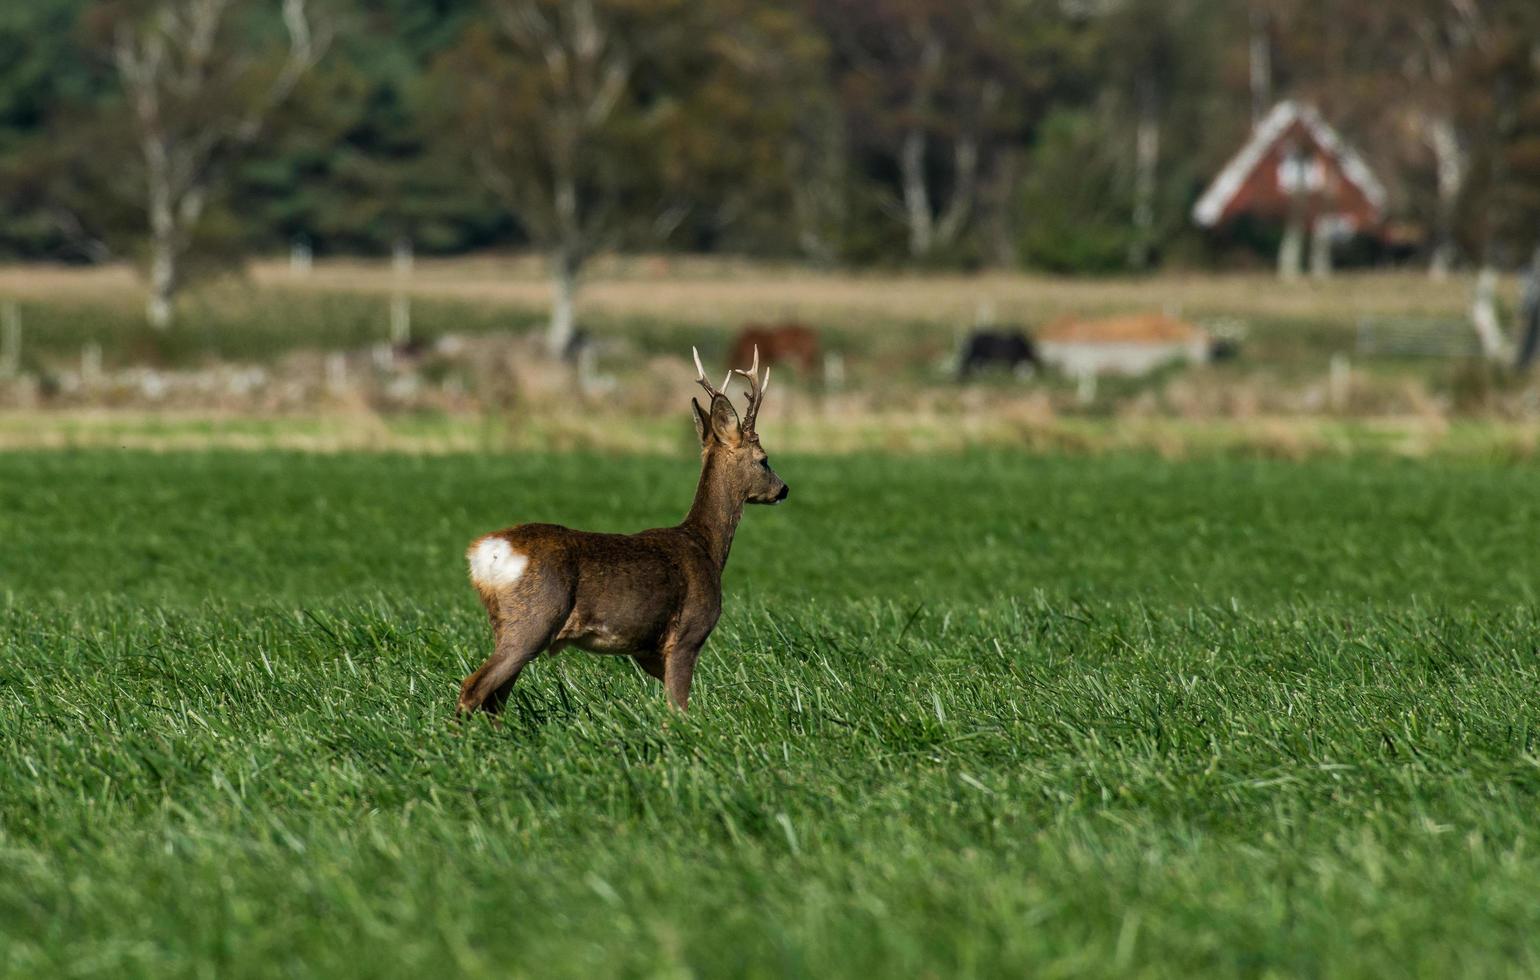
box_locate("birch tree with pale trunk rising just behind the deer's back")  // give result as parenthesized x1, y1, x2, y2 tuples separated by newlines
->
(437, 0, 813, 356)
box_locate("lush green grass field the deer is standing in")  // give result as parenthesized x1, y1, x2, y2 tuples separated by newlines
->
(0, 451, 1540, 977)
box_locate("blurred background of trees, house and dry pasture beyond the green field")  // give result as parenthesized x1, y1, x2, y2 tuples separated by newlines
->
(0, 0, 1540, 455)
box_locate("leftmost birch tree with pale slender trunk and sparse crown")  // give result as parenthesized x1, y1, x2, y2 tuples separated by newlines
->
(106, 0, 330, 328)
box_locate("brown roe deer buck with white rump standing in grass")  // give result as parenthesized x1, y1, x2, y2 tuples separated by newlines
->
(457, 351, 790, 715)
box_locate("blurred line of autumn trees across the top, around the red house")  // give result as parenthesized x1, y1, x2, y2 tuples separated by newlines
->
(0, 0, 1540, 345)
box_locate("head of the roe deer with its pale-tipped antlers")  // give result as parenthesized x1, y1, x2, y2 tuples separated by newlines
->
(690, 347, 792, 504)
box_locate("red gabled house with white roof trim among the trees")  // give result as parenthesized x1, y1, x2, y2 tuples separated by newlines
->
(1192, 102, 1384, 275)
